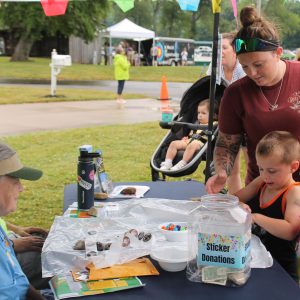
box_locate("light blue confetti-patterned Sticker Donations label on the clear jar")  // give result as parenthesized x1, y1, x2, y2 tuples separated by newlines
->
(197, 233, 251, 269)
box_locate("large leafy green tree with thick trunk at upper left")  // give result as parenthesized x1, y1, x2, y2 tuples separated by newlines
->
(0, 0, 109, 61)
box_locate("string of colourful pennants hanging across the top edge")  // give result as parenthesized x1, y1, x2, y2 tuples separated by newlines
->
(3, 0, 237, 19)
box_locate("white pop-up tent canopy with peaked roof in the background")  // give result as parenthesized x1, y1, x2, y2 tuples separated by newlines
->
(101, 19, 155, 64)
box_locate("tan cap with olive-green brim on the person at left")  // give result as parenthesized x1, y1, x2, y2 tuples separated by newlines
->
(0, 141, 43, 180)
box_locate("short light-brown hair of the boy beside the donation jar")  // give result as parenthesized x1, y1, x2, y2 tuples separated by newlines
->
(256, 131, 300, 164)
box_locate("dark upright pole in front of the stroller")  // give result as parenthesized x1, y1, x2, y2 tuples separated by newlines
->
(205, 12, 220, 182)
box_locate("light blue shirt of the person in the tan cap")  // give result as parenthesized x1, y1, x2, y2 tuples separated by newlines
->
(0, 226, 29, 300)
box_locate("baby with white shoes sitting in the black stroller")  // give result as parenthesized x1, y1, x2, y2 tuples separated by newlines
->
(160, 99, 217, 171)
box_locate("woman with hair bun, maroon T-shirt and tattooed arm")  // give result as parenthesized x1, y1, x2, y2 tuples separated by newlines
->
(206, 7, 300, 193)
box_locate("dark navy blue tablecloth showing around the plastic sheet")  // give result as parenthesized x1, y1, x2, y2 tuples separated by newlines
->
(64, 181, 300, 300)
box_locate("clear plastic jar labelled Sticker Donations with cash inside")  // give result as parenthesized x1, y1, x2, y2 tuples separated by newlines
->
(187, 194, 251, 286)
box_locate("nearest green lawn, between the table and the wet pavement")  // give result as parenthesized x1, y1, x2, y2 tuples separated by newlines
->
(4, 122, 212, 228)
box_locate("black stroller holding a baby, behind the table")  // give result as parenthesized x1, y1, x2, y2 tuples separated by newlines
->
(150, 76, 226, 181)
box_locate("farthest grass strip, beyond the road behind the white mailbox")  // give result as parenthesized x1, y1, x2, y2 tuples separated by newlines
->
(0, 57, 206, 82)
